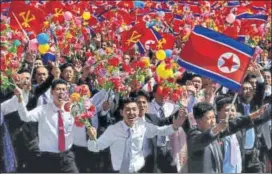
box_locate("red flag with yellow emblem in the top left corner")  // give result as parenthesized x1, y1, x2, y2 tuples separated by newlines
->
(8, 1, 46, 33)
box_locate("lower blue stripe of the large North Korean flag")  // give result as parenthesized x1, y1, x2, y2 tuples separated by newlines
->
(177, 59, 241, 91)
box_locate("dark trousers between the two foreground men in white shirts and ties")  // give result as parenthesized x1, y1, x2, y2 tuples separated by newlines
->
(73, 145, 100, 173)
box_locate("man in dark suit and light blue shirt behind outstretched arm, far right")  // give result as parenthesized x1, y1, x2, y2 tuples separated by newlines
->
(237, 81, 271, 173)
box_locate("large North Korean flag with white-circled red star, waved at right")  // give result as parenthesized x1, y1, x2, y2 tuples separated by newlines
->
(177, 26, 254, 91)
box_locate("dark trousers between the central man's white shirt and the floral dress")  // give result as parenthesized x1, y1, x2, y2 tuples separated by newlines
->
(157, 142, 177, 173)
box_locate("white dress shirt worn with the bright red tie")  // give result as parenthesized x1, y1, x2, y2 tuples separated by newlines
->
(18, 102, 74, 153)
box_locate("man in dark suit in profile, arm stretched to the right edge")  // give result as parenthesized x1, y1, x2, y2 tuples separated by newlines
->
(187, 102, 271, 173)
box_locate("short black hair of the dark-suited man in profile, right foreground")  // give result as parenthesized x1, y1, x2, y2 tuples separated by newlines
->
(193, 102, 214, 119)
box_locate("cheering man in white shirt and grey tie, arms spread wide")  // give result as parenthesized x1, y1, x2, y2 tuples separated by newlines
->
(88, 98, 183, 172)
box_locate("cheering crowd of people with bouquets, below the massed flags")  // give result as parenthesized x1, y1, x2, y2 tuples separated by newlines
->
(0, 0, 272, 173)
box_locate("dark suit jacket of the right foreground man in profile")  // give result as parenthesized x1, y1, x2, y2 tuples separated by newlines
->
(187, 117, 253, 173)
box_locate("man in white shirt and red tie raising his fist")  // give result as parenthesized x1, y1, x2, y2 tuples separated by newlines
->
(15, 79, 78, 173)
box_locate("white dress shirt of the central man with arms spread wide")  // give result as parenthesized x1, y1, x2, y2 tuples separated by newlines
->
(88, 119, 174, 172)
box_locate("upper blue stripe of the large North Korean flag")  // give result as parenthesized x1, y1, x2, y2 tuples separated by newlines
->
(194, 26, 254, 56)
